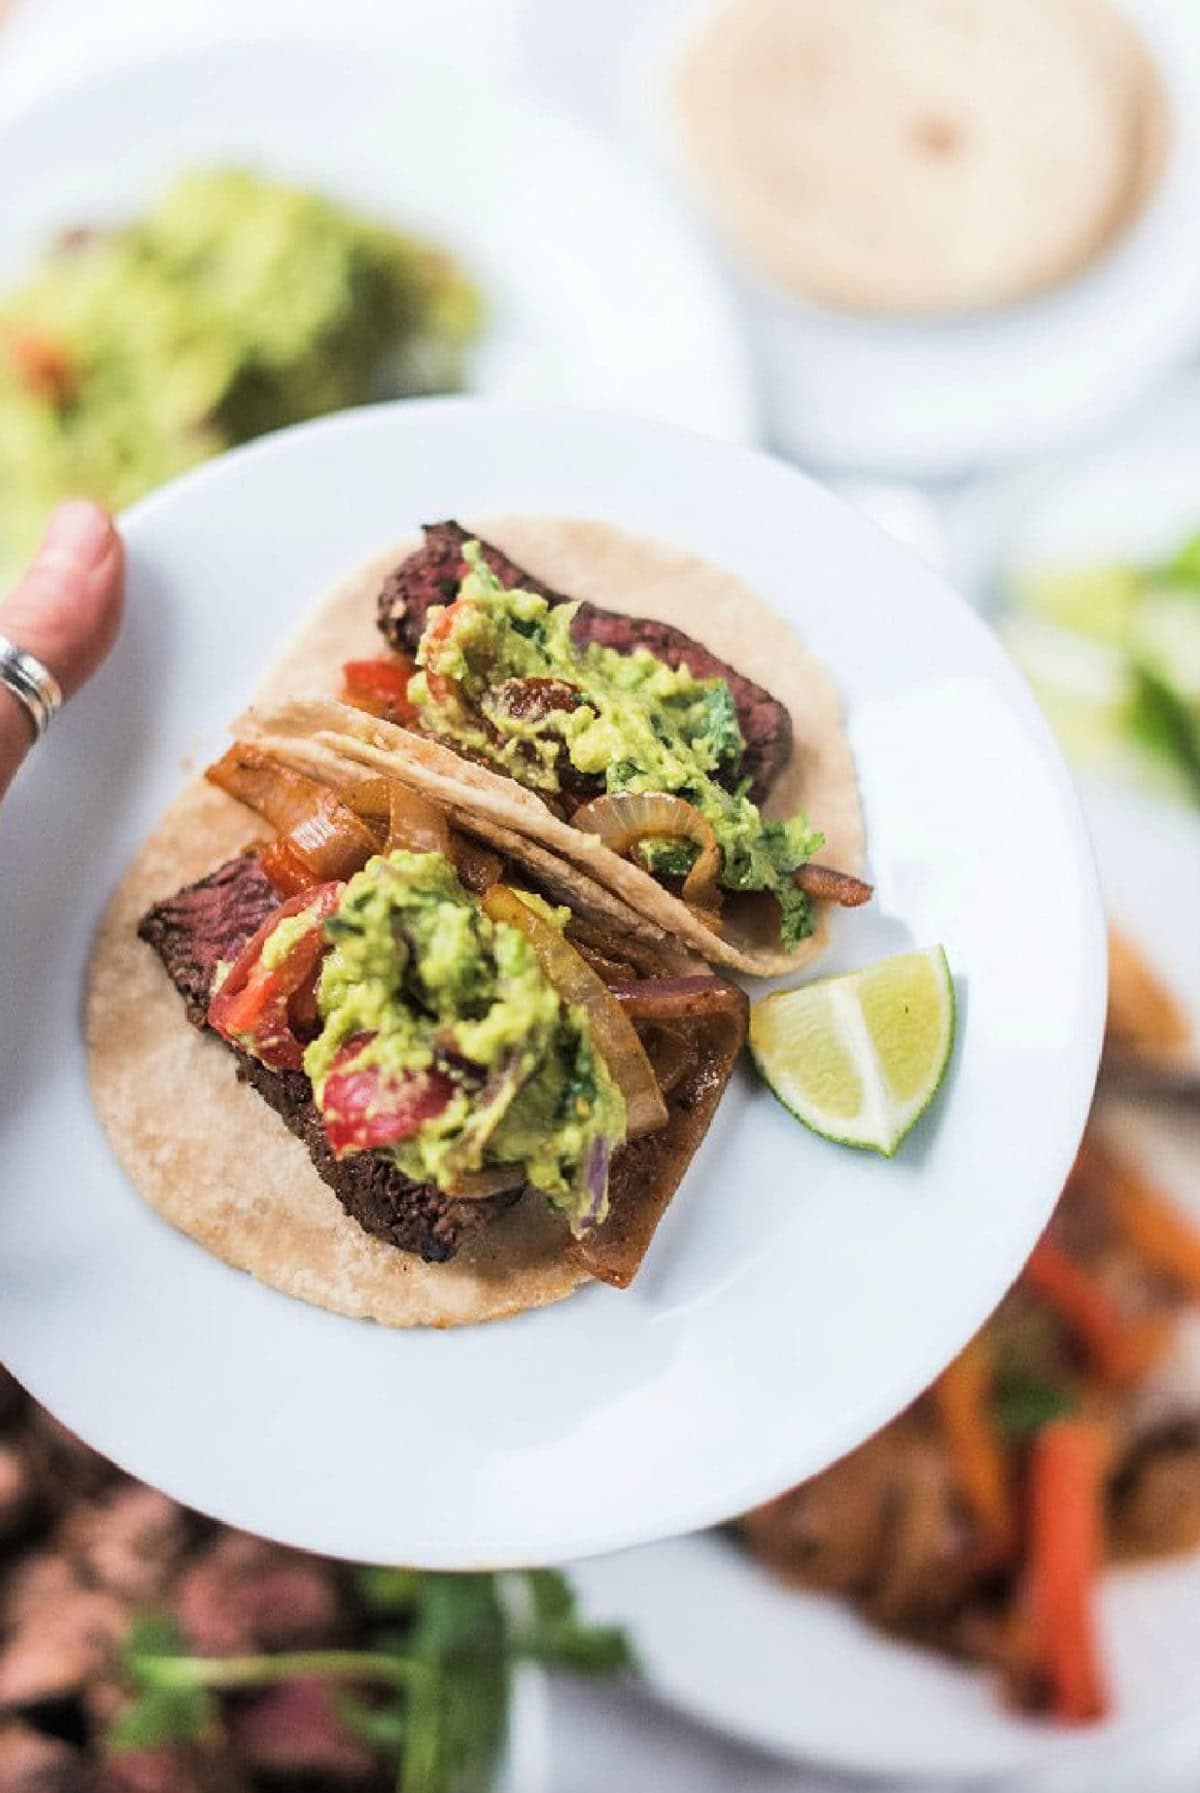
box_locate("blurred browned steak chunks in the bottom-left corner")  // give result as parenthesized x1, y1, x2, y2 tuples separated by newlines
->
(0, 1370, 374, 1793)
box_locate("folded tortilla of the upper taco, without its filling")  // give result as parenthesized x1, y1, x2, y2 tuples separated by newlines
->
(239, 516, 863, 977)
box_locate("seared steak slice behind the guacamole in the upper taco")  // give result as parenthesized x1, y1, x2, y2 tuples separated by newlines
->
(369, 522, 791, 803)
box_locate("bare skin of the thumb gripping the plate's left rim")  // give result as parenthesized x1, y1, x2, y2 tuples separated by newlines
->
(0, 498, 126, 798)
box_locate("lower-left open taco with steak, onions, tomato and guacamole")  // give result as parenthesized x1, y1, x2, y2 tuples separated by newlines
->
(88, 537, 746, 1325)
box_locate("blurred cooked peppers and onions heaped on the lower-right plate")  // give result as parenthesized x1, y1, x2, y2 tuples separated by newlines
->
(741, 934, 1200, 1723)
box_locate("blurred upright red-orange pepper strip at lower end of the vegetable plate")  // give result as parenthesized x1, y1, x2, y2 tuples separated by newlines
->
(1030, 1418, 1110, 1723)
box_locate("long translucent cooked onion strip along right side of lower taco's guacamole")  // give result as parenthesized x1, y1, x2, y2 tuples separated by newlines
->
(483, 884, 667, 1139)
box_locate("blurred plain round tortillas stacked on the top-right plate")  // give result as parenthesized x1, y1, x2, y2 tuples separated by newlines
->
(674, 0, 1170, 314)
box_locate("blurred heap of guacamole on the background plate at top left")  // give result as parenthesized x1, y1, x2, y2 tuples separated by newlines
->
(0, 169, 479, 577)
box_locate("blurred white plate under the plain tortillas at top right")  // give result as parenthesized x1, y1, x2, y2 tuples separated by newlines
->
(524, 0, 1200, 479)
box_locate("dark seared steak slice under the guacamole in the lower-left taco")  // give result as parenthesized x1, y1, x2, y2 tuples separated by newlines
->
(138, 853, 517, 1264)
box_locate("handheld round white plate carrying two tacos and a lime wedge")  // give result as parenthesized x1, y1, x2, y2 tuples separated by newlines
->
(0, 400, 1105, 1567)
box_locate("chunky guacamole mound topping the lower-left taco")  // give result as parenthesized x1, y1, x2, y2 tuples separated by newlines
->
(294, 852, 626, 1226)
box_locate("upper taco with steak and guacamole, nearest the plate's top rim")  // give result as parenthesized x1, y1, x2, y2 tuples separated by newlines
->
(246, 518, 872, 975)
